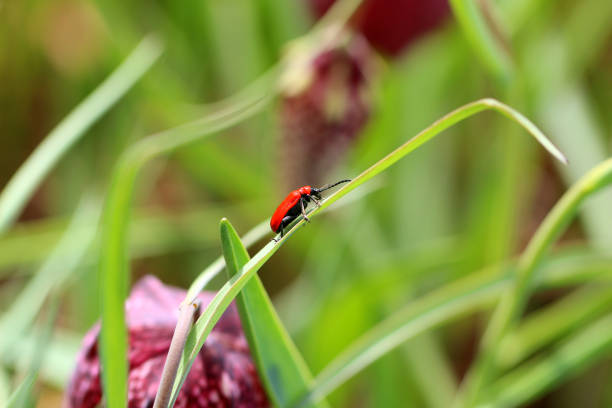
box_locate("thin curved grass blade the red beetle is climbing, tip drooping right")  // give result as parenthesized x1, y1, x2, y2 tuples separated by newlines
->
(172, 99, 566, 401)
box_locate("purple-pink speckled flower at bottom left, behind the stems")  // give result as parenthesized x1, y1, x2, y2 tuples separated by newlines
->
(66, 276, 269, 408)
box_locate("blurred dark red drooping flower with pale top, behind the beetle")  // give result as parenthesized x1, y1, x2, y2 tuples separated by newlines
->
(280, 34, 374, 189)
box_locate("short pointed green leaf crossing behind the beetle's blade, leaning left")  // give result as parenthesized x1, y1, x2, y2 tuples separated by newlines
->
(220, 219, 326, 407)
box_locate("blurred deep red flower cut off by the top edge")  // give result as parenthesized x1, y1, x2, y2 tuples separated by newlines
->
(308, 0, 449, 56)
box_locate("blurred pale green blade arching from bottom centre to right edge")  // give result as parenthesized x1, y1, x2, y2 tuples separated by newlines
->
(294, 253, 611, 401)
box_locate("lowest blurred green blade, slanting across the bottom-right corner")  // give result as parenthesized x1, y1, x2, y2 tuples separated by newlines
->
(477, 315, 612, 408)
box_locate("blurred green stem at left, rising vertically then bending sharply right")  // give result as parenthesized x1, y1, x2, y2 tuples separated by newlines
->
(99, 68, 276, 408)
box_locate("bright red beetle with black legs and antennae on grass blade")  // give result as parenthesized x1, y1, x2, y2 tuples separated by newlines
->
(270, 180, 351, 238)
